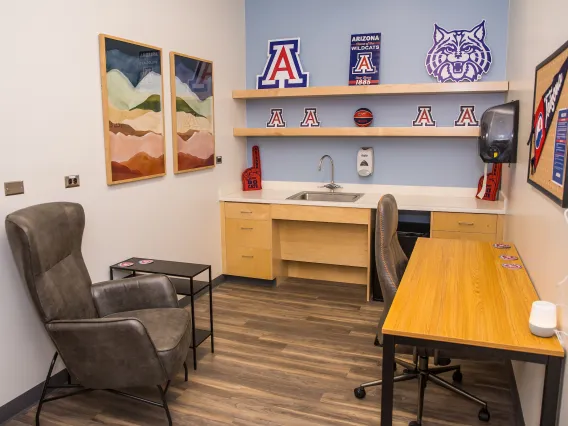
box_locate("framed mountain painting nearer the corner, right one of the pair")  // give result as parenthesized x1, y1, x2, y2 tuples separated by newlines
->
(170, 52, 215, 173)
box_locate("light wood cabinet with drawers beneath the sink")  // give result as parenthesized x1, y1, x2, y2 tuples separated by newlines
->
(221, 202, 372, 297)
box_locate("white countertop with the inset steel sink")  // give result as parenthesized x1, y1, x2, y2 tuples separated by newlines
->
(219, 182, 506, 214)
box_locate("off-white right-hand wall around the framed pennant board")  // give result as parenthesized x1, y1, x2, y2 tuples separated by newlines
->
(504, 0, 568, 426)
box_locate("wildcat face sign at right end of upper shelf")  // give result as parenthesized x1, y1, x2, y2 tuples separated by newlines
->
(426, 21, 492, 83)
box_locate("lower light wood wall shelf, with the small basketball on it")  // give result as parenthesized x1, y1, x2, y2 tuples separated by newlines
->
(233, 127, 479, 138)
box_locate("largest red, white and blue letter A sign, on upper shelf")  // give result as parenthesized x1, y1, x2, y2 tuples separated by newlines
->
(256, 38, 310, 89)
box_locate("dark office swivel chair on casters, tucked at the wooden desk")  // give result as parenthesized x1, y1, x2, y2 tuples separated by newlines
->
(354, 194, 490, 426)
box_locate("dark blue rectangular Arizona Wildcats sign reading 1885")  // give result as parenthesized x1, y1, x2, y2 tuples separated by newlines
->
(349, 33, 381, 86)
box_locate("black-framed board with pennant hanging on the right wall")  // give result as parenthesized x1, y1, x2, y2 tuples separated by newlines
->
(527, 42, 568, 207)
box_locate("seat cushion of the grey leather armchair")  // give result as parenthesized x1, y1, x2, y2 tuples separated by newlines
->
(105, 308, 191, 377)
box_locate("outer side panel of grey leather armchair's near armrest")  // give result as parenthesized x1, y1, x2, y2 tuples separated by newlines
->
(45, 318, 168, 389)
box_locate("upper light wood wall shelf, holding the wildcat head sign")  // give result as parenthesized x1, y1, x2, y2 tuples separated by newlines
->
(233, 81, 509, 99)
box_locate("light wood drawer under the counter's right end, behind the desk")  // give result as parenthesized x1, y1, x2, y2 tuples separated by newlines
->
(430, 212, 503, 241)
